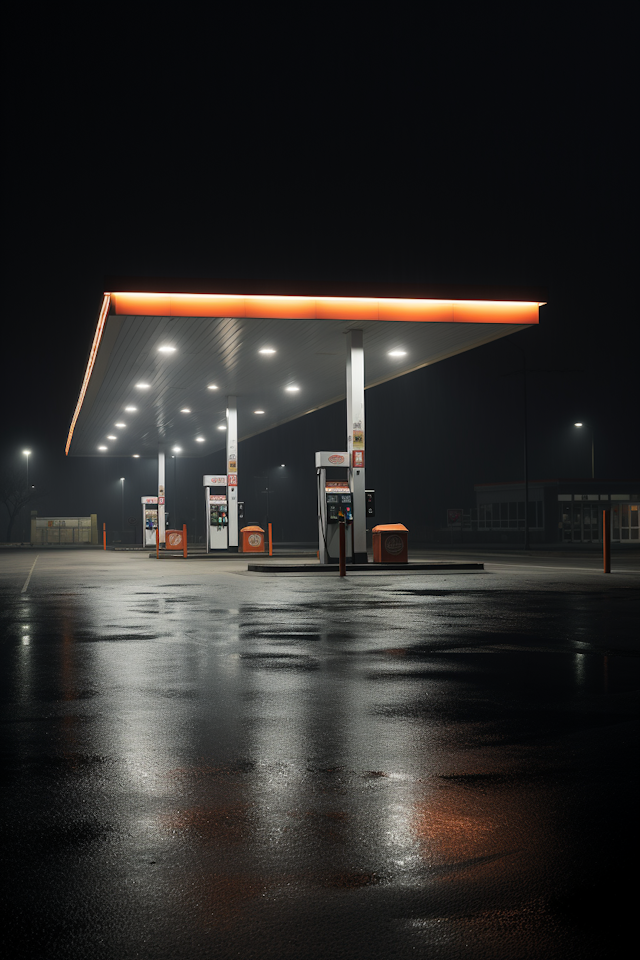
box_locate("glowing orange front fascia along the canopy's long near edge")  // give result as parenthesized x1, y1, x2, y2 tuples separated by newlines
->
(109, 291, 540, 324)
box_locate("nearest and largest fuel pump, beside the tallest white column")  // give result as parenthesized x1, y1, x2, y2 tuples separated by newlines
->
(316, 451, 353, 563)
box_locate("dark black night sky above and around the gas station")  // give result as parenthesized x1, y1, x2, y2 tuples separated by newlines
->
(1, 14, 640, 531)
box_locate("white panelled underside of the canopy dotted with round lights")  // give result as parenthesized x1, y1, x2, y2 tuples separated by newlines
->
(69, 314, 527, 457)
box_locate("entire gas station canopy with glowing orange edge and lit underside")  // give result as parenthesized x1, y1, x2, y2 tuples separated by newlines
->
(66, 281, 544, 457)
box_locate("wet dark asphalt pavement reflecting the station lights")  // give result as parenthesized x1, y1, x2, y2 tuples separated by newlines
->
(0, 550, 640, 960)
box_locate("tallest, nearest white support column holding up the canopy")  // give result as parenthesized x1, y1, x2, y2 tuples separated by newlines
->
(347, 330, 367, 563)
